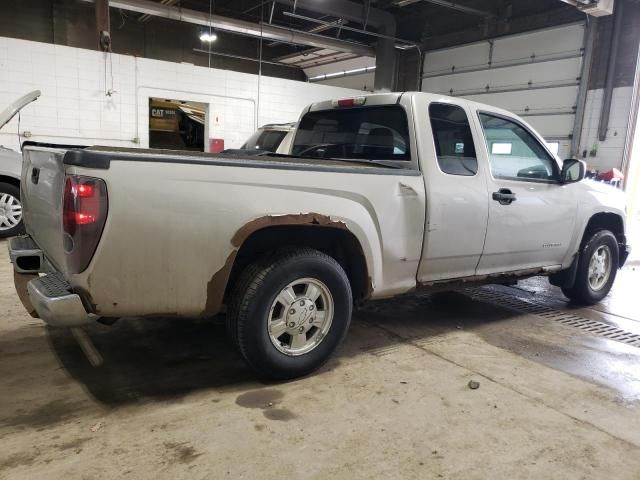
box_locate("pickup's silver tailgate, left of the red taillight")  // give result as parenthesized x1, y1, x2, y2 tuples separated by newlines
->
(21, 145, 67, 271)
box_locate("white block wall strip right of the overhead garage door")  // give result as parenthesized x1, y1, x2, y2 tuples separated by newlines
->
(579, 87, 633, 171)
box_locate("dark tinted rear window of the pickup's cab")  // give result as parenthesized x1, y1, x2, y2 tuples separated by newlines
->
(291, 105, 411, 161)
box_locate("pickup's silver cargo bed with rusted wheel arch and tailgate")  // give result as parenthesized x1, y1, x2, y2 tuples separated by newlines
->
(22, 145, 425, 317)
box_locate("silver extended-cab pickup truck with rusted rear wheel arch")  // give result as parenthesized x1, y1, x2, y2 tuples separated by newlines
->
(9, 93, 627, 378)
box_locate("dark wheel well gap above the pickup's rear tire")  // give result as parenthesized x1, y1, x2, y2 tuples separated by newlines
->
(225, 225, 371, 303)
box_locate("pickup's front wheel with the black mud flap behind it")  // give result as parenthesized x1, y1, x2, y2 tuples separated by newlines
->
(562, 230, 619, 305)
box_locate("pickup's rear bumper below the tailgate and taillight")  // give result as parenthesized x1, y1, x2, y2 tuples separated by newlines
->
(9, 236, 92, 327)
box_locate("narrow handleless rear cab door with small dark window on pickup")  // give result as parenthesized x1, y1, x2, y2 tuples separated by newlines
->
(415, 98, 488, 284)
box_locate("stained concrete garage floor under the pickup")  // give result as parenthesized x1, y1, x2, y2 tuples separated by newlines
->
(0, 242, 640, 480)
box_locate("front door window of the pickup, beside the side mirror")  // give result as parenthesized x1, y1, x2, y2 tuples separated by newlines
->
(479, 113, 559, 181)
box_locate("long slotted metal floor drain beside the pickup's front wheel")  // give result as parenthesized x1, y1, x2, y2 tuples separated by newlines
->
(465, 288, 640, 348)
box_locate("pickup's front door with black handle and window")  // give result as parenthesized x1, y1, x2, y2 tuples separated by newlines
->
(474, 112, 577, 275)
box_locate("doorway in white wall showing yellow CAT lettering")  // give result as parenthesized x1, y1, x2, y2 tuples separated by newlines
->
(149, 97, 207, 152)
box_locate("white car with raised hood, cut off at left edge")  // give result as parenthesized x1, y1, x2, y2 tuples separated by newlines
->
(0, 90, 40, 238)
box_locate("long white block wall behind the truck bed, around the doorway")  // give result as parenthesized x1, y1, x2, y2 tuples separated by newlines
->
(0, 37, 358, 149)
